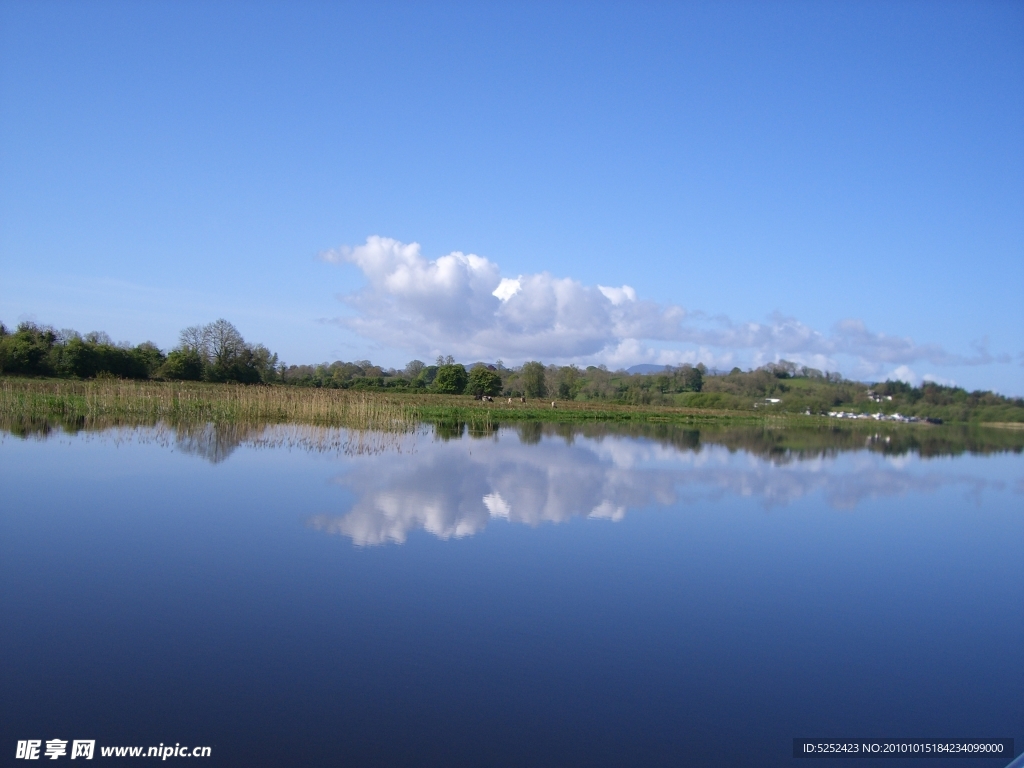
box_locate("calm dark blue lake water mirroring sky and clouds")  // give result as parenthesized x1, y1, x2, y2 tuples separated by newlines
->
(0, 426, 1024, 767)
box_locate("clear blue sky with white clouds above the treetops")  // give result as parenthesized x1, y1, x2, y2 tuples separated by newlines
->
(0, 0, 1024, 395)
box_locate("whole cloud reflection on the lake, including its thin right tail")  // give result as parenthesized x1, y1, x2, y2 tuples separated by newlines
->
(308, 430, 1002, 546)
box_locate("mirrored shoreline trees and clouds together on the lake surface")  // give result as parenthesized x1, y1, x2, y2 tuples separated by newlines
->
(0, 415, 1024, 546)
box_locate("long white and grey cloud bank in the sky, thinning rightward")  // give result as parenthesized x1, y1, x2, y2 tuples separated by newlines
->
(321, 236, 1011, 380)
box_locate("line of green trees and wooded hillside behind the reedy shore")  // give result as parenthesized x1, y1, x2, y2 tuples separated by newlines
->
(0, 319, 1024, 422)
